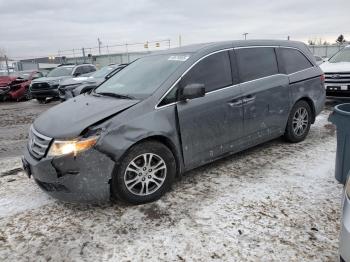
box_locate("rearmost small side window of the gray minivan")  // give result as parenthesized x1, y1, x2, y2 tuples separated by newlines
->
(280, 48, 313, 74)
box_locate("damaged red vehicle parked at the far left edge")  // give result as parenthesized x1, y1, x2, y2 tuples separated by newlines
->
(0, 71, 44, 101)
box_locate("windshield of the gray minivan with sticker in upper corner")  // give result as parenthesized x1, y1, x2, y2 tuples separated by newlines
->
(95, 54, 189, 98)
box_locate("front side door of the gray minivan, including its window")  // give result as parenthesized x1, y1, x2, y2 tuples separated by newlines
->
(176, 50, 243, 168)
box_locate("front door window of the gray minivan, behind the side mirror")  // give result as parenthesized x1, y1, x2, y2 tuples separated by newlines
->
(181, 51, 232, 92)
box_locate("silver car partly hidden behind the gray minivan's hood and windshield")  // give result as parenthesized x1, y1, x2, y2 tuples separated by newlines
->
(58, 64, 127, 101)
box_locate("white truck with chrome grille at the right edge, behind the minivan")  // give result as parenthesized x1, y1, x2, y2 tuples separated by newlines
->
(320, 46, 350, 97)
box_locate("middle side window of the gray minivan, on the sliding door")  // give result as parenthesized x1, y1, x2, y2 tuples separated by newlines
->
(235, 47, 278, 82)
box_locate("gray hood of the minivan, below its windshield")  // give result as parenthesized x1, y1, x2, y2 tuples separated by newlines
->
(34, 95, 139, 139)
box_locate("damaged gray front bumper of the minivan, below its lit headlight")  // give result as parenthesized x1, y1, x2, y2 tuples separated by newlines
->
(23, 148, 115, 203)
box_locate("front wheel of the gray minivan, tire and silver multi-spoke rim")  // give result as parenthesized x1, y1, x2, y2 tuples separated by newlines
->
(111, 141, 176, 204)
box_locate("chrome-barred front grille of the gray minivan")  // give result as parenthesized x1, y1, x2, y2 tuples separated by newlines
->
(28, 126, 52, 159)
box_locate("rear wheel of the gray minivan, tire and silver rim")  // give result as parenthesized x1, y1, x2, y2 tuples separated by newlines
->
(284, 100, 313, 143)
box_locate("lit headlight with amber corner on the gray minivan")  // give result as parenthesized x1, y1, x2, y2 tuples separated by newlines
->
(48, 136, 98, 156)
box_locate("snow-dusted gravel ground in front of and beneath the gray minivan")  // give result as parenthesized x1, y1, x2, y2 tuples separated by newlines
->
(0, 100, 342, 261)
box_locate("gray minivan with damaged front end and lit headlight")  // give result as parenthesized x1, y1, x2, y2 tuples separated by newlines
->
(23, 40, 325, 204)
